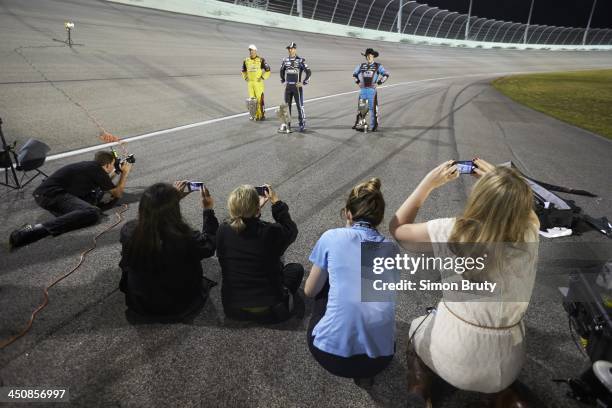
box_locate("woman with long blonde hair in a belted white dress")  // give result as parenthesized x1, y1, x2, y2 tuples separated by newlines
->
(389, 159, 539, 407)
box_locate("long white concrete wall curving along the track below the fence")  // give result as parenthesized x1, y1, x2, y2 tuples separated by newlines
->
(107, 0, 612, 51)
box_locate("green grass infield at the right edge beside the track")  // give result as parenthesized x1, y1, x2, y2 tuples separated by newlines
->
(492, 69, 612, 139)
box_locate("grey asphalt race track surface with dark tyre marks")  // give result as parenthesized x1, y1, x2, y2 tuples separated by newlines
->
(0, 0, 612, 407)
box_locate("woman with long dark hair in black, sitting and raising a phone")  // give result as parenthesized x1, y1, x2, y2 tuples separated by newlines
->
(119, 181, 219, 320)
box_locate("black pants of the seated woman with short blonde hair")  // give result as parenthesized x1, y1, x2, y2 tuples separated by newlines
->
(223, 263, 304, 323)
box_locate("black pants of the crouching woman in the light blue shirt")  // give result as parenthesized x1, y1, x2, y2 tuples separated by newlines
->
(306, 281, 393, 378)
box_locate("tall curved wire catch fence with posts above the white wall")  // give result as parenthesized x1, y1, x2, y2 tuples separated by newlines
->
(232, 0, 612, 46)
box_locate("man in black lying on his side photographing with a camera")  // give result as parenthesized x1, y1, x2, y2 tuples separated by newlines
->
(9, 151, 132, 249)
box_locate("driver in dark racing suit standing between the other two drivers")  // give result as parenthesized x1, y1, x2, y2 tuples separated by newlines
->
(280, 42, 311, 132)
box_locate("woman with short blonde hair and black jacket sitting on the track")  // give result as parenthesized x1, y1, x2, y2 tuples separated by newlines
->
(217, 185, 304, 322)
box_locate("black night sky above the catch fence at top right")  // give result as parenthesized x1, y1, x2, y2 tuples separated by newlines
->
(419, 0, 612, 28)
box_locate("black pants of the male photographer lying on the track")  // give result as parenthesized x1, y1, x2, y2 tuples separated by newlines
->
(34, 193, 100, 236)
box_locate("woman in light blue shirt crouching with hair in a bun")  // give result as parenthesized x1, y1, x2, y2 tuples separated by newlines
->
(304, 178, 395, 385)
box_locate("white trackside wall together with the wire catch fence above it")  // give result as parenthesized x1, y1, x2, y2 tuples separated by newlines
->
(107, 0, 612, 51)
